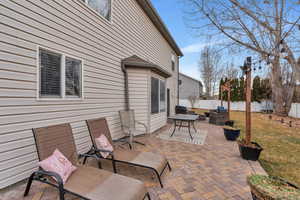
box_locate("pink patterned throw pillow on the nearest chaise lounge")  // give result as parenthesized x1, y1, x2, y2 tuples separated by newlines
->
(39, 149, 77, 184)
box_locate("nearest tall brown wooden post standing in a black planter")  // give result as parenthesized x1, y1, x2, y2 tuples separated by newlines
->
(244, 57, 252, 145)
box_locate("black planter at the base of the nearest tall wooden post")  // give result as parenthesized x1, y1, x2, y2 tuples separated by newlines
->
(239, 142, 263, 161)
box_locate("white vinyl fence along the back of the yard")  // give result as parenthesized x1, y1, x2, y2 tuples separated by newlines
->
(179, 99, 300, 118)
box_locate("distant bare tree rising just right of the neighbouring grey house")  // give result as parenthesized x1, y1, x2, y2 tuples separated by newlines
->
(198, 46, 222, 97)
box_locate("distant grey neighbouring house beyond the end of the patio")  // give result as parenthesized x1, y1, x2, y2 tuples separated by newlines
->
(179, 73, 203, 100)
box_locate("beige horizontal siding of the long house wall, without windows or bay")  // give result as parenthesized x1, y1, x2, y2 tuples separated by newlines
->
(0, 0, 177, 188)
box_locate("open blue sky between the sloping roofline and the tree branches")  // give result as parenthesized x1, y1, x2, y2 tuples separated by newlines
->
(152, 0, 205, 80)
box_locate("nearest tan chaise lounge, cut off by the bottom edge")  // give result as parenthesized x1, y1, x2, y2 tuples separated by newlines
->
(24, 124, 150, 200)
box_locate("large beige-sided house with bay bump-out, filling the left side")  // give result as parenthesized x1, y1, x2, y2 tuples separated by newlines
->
(0, 0, 182, 189)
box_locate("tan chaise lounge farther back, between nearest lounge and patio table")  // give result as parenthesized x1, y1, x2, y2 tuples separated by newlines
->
(83, 118, 171, 187)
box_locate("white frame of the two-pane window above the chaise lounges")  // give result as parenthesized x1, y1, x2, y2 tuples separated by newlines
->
(36, 45, 84, 101)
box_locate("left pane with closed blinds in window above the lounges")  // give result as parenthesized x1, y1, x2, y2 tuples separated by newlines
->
(39, 49, 61, 97)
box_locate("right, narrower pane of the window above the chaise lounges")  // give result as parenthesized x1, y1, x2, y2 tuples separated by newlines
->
(65, 57, 82, 97)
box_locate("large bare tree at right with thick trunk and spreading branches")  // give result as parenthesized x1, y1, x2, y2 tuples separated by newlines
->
(184, 0, 300, 115)
